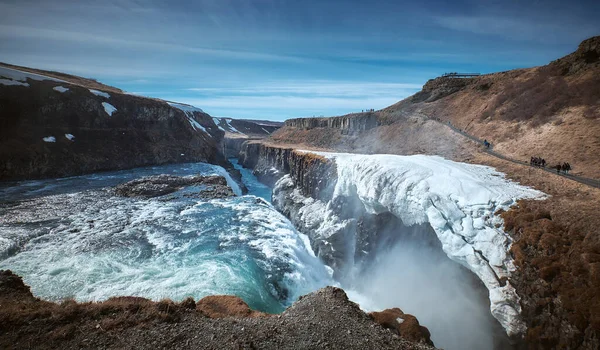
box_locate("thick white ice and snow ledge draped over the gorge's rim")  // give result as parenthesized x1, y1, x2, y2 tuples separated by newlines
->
(290, 151, 545, 336)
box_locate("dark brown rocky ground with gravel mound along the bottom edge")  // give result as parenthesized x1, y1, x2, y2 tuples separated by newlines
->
(0, 270, 433, 349)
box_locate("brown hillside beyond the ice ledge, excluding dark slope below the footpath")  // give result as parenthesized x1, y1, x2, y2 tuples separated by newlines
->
(272, 36, 600, 178)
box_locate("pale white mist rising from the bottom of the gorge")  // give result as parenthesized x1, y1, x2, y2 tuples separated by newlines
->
(345, 226, 510, 350)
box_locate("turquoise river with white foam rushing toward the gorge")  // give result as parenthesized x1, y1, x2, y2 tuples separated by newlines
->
(0, 163, 331, 313)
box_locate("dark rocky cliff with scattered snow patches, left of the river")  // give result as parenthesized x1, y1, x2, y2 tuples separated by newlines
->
(0, 67, 229, 181)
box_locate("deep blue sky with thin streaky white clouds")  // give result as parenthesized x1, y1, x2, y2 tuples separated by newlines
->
(0, 0, 600, 120)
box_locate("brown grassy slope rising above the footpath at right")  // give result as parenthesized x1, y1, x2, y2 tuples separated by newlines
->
(381, 37, 600, 178)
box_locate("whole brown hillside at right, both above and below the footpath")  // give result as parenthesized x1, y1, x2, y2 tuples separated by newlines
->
(265, 37, 600, 349)
